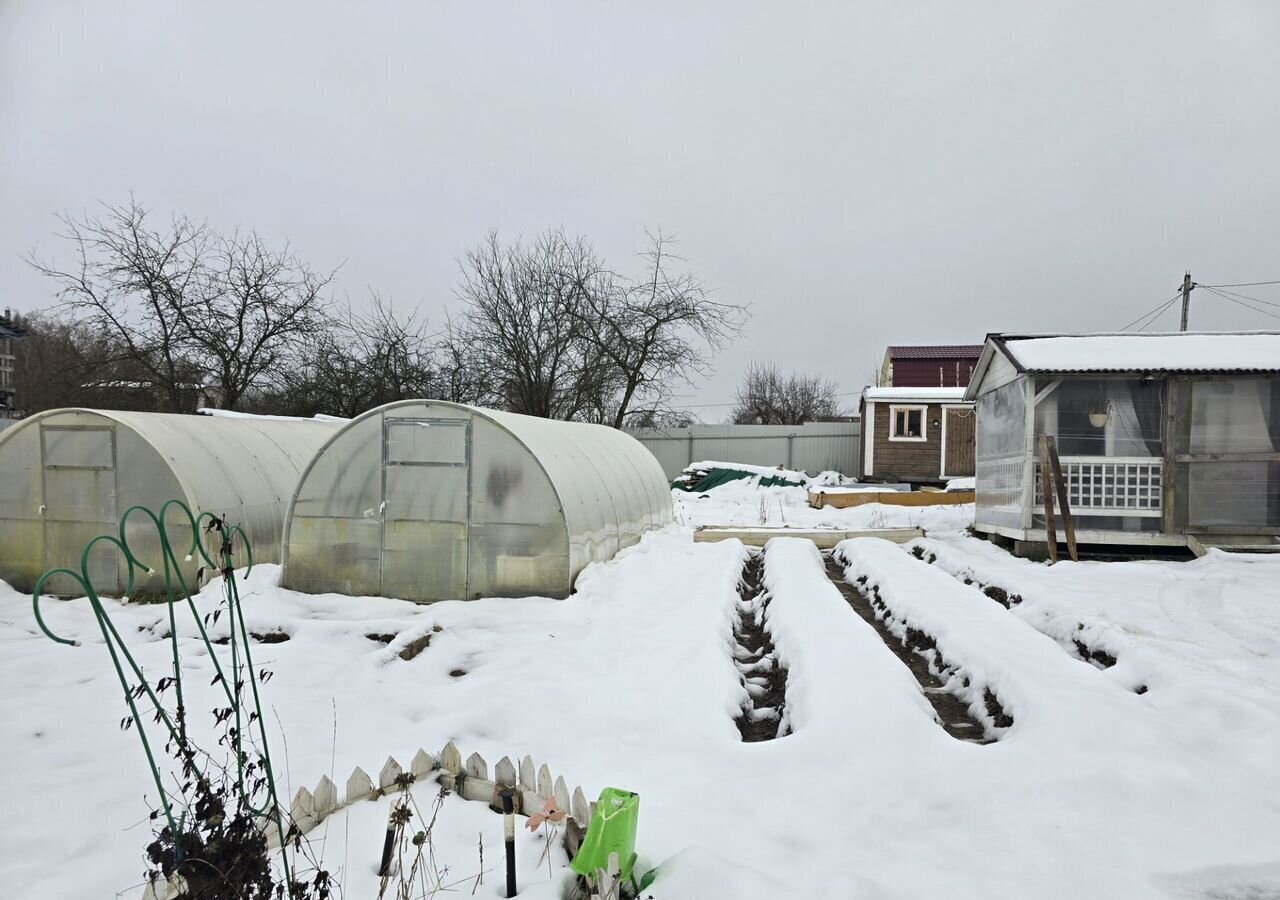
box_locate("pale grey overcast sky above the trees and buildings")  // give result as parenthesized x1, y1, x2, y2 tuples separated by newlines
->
(0, 0, 1280, 421)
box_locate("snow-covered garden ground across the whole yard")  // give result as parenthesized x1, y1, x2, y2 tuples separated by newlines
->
(0, 481, 1280, 900)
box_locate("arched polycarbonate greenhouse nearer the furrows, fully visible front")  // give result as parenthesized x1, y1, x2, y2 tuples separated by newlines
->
(284, 401, 671, 600)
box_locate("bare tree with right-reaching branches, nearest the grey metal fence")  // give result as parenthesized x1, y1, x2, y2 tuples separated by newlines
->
(573, 232, 746, 428)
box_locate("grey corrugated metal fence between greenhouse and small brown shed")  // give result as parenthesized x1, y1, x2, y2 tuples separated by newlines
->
(627, 422, 861, 479)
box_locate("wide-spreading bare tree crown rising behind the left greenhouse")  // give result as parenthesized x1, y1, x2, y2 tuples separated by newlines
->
(28, 201, 333, 412)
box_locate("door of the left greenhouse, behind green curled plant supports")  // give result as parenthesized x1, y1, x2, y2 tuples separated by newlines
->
(40, 425, 120, 594)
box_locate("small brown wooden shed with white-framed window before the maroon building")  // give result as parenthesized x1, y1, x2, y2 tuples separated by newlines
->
(861, 387, 974, 484)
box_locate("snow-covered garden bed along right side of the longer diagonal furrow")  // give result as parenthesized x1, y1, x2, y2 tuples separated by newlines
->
(836, 538, 1106, 737)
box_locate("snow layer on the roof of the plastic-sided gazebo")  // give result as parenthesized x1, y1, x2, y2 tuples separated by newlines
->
(992, 332, 1280, 371)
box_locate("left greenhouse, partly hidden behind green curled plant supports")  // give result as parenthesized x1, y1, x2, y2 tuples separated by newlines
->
(0, 410, 339, 595)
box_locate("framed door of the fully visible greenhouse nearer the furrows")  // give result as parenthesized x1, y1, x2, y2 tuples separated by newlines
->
(383, 419, 471, 600)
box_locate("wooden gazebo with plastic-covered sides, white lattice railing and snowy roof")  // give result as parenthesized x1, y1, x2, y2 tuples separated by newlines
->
(965, 332, 1280, 553)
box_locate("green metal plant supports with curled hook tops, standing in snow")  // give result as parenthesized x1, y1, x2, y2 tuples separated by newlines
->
(32, 501, 292, 896)
